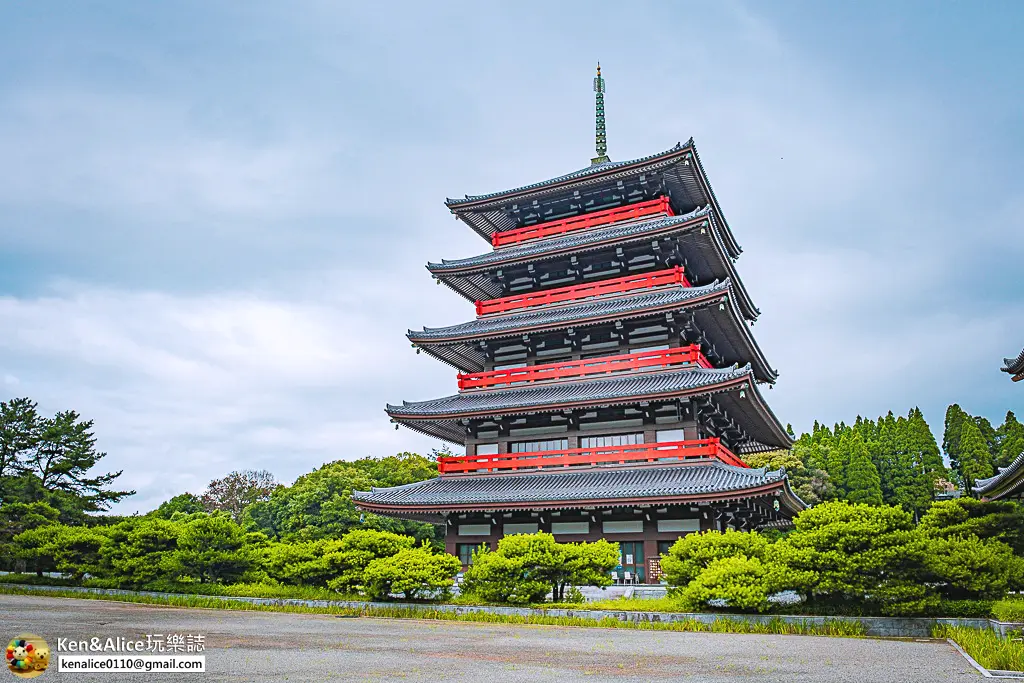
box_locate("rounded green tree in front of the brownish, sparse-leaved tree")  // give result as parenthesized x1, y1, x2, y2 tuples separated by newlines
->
(167, 515, 255, 584)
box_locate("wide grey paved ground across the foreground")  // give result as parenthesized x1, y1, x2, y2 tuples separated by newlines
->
(0, 595, 981, 683)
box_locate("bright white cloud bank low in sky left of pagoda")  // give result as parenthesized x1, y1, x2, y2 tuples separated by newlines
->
(0, 278, 454, 510)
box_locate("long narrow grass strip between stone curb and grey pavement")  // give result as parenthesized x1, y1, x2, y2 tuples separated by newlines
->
(0, 585, 864, 638)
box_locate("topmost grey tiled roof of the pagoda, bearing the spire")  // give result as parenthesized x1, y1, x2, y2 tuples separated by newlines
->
(445, 138, 742, 257)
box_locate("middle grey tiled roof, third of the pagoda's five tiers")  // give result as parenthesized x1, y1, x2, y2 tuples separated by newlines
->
(408, 280, 778, 382)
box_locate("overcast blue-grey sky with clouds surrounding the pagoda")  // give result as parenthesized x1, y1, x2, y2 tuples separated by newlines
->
(0, 0, 1024, 512)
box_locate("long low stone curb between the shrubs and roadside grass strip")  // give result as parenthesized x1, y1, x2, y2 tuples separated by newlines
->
(0, 583, 1024, 643)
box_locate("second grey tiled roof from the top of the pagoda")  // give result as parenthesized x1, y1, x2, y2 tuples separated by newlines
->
(427, 205, 761, 319)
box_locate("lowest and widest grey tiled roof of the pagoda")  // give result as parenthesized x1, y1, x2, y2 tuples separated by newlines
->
(352, 460, 807, 516)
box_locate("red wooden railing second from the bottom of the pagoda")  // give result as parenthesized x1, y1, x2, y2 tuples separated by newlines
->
(459, 344, 712, 391)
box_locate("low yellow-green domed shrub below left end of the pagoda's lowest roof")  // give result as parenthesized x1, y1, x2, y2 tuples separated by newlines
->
(364, 547, 462, 600)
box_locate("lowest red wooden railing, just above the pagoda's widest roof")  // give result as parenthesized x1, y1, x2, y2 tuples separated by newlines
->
(437, 438, 746, 474)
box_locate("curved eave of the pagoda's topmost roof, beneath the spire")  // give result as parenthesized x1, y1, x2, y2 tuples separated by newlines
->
(444, 137, 742, 258)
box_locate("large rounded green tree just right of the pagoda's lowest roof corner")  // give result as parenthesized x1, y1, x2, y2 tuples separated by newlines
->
(771, 502, 930, 613)
